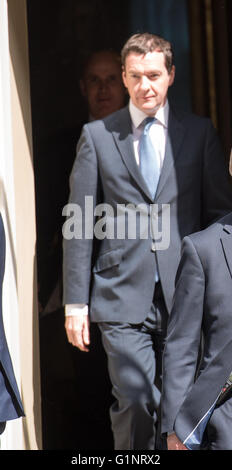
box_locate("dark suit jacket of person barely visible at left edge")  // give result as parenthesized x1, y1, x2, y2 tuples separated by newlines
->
(0, 215, 24, 421)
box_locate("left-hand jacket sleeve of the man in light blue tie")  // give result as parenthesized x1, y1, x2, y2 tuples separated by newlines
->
(63, 125, 98, 304)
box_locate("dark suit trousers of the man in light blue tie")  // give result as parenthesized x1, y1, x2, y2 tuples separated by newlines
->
(99, 283, 167, 450)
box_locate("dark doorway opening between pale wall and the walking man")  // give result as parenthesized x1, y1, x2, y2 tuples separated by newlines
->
(28, 0, 132, 449)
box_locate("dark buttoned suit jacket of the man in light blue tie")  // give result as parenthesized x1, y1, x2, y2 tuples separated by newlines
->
(63, 107, 232, 323)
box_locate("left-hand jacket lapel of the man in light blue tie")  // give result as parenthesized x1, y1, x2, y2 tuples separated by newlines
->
(112, 107, 153, 202)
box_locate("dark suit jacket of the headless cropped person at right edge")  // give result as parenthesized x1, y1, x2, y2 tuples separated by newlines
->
(162, 213, 232, 449)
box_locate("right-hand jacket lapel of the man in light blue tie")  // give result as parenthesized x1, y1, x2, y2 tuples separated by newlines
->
(156, 107, 185, 199)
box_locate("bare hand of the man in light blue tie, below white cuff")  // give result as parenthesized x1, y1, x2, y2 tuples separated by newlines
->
(65, 314, 90, 352)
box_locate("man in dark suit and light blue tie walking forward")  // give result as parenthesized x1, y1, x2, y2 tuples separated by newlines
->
(63, 33, 232, 449)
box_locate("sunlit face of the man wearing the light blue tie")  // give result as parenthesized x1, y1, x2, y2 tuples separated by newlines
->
(122, 51, 175, 116)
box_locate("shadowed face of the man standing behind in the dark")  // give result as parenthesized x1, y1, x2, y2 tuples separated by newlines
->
(81, 52, 125, 119)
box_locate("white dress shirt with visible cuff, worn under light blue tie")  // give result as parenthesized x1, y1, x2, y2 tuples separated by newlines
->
(65, 100, 169, 316)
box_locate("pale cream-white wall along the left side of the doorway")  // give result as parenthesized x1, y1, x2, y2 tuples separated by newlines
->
(0, 0, 41, 450)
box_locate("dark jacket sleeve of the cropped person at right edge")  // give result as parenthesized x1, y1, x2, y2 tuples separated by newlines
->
(162, 237, 205, 433)
